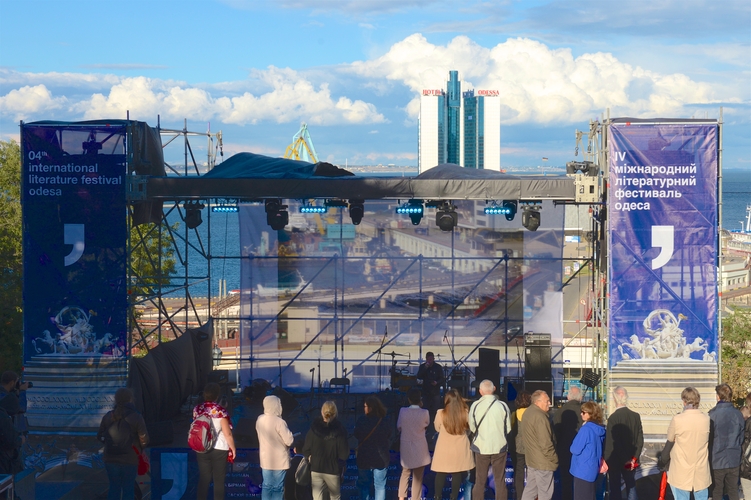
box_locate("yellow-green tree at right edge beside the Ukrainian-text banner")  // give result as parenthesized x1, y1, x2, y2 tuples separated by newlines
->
(722, 308, 751, 398)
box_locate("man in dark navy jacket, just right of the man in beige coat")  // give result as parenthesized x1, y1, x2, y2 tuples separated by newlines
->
(709, 384, 745, 500)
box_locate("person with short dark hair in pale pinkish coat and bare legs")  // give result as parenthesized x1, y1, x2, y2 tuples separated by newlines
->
(396, 389, 430, 500)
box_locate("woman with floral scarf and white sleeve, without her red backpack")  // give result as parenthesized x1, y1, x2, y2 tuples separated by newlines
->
(193, 382, 237, 500)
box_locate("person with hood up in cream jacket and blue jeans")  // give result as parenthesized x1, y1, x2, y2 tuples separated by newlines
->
(256, 396, 295, 500)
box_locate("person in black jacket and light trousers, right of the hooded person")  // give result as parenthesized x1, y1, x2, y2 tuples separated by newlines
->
(303, 401, 349, 500)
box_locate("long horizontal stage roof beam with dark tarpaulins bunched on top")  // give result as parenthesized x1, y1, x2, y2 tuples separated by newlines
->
(146, 153, 575, 200)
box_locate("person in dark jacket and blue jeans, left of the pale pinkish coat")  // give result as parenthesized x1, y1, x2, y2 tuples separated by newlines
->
(355, 396, 392, 500)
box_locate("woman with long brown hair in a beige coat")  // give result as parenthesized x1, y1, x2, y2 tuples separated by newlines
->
(430, 389, 475, 500)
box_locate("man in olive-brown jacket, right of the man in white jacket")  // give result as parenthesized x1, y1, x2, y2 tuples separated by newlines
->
(522, 391, 558, 500)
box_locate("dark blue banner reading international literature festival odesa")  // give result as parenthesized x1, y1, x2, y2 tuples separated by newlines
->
(21, 121, 127, 430)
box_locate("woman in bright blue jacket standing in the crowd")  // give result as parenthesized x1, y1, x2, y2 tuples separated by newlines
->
(569, 401, 605, 500)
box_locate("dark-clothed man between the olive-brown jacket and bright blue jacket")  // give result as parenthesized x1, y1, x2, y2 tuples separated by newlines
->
(553, 385, 583, 500)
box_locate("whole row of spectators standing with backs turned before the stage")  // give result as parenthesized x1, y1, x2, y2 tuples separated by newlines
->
(0, 367, 751, 500)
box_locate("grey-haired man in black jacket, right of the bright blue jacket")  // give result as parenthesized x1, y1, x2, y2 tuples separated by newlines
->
(604, 386, 644, 500)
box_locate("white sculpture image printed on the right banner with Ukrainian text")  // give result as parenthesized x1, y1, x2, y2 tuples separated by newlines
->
(618, 309, 717, 361)
